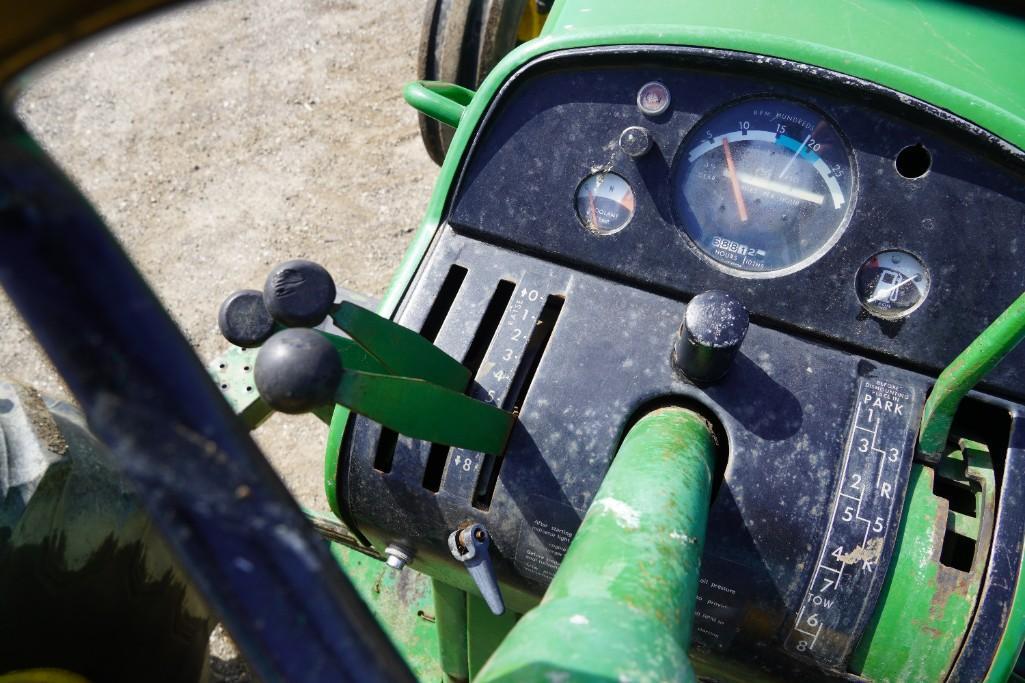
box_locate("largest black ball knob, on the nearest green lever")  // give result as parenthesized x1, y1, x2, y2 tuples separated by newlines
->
(253, 327, 342, 414)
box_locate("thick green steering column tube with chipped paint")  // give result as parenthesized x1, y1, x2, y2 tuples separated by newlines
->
(478, 408, 715, 681)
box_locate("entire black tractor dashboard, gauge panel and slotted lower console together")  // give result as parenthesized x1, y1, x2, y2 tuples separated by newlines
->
(338, 47, 1025, 680)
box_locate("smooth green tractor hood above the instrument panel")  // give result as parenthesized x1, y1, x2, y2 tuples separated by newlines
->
(534, 0, 1025, 149)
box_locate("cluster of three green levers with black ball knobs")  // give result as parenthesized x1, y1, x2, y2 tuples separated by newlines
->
(219, 260, 516, 455)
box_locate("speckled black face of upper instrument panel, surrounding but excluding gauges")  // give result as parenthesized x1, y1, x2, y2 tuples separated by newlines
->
(449, 48, 1025, 399)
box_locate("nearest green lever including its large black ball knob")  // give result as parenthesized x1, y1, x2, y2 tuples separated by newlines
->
(254, 328, 516, 454)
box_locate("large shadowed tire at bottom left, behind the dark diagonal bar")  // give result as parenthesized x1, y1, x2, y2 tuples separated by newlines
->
(0, 380, 214, 683)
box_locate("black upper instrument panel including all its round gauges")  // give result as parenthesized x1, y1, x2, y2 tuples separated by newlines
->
(448, 47, 1025, 398)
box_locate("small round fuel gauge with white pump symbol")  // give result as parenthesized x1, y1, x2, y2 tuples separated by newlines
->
(857, 249, 930, 320)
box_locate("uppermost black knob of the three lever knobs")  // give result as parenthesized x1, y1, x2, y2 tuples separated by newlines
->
(263, 258, 336, 327)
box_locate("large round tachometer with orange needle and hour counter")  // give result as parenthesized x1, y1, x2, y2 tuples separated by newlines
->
(673, 99, 854, 275)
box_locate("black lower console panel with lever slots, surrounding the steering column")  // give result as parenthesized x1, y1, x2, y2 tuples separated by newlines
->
(341, 229, 951, 675)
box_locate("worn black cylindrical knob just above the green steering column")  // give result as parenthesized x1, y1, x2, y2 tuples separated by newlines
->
(672, 289, 748, 384)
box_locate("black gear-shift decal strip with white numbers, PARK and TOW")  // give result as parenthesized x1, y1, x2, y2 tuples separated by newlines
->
(785, 378, 917, 671)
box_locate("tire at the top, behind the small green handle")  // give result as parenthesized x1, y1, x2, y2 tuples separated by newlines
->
(417, 0, 533, 166)
